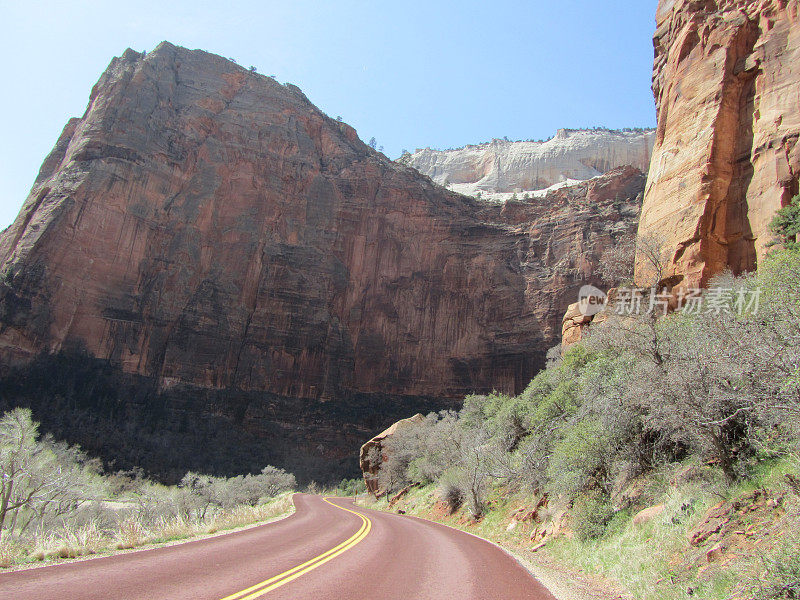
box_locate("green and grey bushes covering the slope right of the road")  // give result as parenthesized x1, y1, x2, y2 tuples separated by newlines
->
(379, 246, 800, 508)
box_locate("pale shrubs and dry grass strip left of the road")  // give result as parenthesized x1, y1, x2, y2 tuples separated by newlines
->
(0, 409, 295, 567)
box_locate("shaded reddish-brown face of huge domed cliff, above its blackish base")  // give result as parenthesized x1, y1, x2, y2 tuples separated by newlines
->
(0, 45, 540, 399)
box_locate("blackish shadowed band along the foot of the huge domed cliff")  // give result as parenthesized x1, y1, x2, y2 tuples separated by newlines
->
(0, 350, 441, 484)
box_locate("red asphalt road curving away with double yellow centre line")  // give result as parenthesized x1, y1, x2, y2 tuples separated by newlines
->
(0, 494, 555, 600)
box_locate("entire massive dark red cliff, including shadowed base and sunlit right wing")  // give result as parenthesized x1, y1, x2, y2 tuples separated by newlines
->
(0, 43, 643, 477)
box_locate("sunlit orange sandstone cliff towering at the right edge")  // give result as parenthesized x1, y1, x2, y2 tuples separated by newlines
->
(638, 0, 800, 287)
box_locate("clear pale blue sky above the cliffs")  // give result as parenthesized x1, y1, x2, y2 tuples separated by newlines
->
(0, 0, 656, 229)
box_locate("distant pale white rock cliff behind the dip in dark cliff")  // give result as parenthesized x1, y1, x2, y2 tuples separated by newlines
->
(404, 129, 655, 199)
